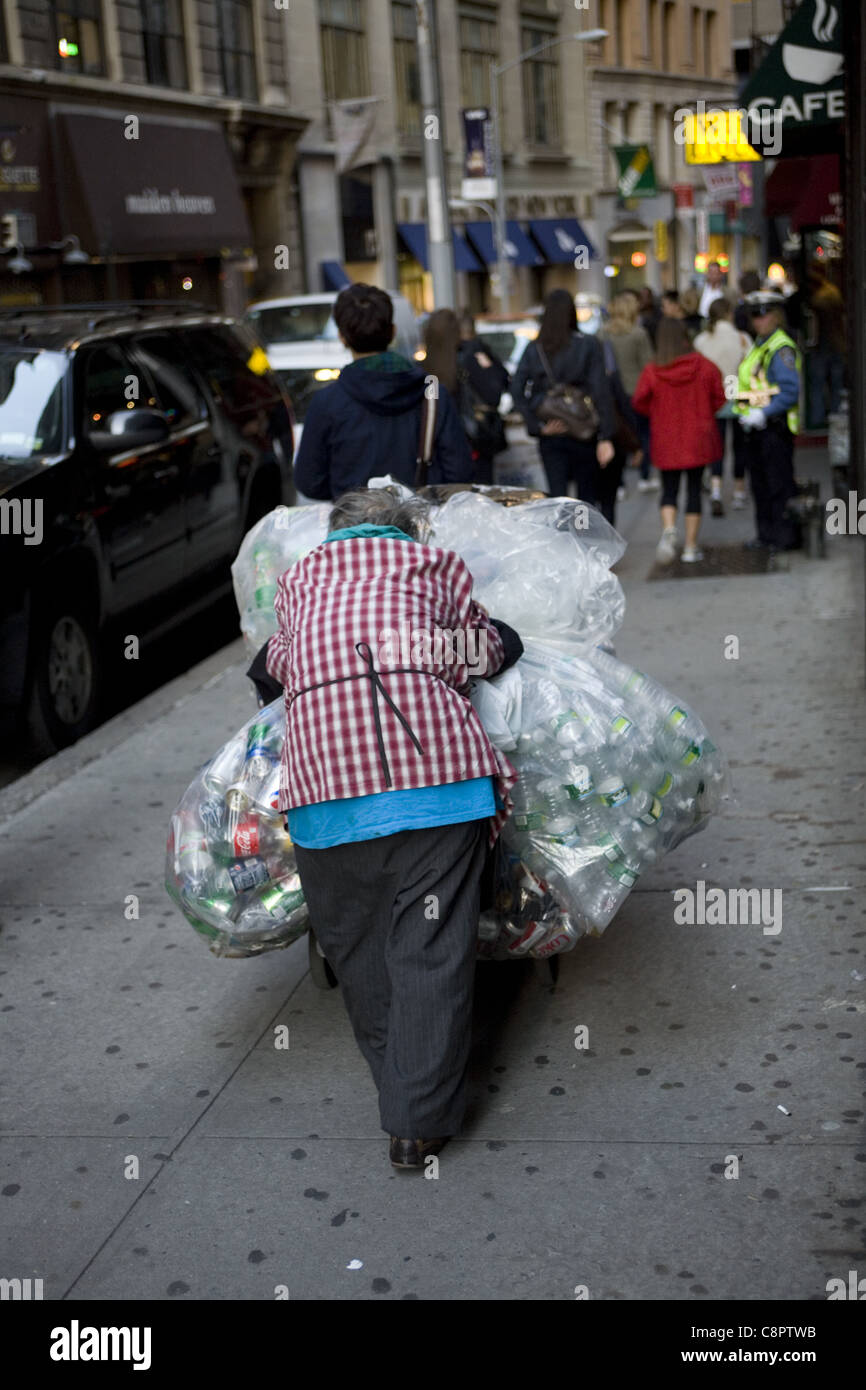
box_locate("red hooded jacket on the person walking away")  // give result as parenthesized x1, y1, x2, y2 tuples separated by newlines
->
(631, 352, 726, 468)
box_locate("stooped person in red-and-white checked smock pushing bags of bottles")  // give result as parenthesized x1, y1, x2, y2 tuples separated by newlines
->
(267, 489, 523, 1168)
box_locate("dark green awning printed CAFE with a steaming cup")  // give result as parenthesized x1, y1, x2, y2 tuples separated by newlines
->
(740, 0, 858, 156)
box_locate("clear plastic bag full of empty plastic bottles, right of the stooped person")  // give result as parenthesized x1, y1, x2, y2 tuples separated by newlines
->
(503, 639, 728, 934)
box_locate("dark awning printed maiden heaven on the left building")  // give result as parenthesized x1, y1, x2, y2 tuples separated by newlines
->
(51, 107, 252, 259)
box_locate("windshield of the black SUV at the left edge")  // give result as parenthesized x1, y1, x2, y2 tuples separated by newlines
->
(0, 345, 67, 460)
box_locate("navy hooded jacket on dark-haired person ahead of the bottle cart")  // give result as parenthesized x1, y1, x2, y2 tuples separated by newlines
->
(295, 352, 473, 500)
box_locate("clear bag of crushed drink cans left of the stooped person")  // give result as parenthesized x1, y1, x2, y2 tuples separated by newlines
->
(165, 699, 309, 958)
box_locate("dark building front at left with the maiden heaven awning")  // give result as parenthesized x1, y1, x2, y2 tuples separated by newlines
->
(0, 0, 306, 313)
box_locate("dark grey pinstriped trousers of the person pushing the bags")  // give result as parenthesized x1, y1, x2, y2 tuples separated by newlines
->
(295, 819, 489, 1138)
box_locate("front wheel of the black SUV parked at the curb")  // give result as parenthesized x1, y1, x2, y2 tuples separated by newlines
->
(26, 595, 100, 753)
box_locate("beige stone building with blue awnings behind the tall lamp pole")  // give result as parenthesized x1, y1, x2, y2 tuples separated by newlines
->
(289, 0, 603, 310)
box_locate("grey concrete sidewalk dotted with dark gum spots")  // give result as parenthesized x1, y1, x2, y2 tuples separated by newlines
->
(0, 447, 866, 1302)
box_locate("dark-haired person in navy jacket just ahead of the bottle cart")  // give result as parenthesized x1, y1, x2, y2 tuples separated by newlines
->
(295, 284, 473, 500)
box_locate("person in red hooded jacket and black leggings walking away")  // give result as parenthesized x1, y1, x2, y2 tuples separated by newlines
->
(631, 318, 724, 564)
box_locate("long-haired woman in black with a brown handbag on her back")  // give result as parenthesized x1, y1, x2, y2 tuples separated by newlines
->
(514, 289, 616, 505)
